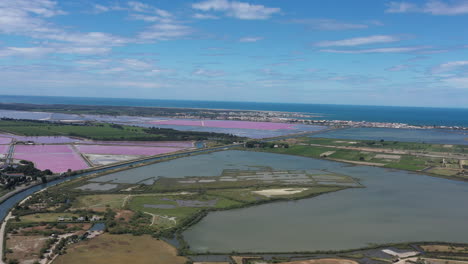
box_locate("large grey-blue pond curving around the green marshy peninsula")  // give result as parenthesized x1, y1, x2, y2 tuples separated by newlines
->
(140, 151, 468, 252)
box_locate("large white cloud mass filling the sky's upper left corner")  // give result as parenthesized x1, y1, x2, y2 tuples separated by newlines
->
(0, 0, 129, 56)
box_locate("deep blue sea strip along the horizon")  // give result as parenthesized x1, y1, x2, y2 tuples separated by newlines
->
(0, 95, 468, 127)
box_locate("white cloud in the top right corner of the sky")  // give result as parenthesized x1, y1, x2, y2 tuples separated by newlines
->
(386, 0, 468, 15)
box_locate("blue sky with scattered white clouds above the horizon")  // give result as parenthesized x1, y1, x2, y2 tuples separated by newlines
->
(0, 0, 468, 107)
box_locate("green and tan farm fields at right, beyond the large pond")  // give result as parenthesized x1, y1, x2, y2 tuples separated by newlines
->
(254, 137, 468, 179)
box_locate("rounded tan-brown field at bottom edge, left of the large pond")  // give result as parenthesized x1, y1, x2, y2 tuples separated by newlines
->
(54, 234, 187, 264)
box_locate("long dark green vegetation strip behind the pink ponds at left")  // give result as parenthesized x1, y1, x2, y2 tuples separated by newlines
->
(0, 119, 241, 143)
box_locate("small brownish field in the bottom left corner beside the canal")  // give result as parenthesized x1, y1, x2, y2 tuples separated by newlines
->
(6, 236, 49, 263)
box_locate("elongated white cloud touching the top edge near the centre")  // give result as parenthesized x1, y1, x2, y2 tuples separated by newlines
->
(192, 0, 281, 20)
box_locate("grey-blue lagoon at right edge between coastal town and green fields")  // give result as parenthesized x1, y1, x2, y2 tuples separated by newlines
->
(312, 127, 468, 145)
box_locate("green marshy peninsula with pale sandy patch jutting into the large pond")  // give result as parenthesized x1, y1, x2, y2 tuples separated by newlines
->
(9, 168, 352, 249)
